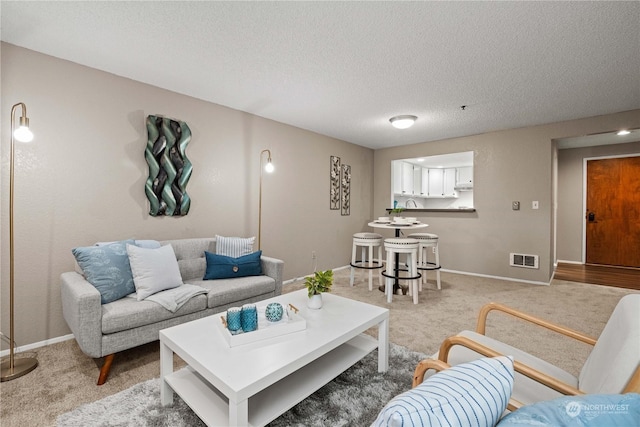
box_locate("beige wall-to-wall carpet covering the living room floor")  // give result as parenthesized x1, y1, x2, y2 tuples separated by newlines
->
(0, 269, 638, 427)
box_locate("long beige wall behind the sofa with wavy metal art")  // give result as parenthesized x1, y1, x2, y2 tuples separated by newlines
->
(1, 44, 373, 348)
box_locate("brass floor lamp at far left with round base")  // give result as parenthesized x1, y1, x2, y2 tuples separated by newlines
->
(0, 102, 38, 381)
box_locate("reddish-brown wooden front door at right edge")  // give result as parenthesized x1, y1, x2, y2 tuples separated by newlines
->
(586, 156, 640, 267)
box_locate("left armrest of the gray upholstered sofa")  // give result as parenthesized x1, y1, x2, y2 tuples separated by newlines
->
(60, 271, 104, 358)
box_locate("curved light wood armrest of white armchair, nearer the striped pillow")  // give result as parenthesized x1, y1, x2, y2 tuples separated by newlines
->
(438, 335, 585, 395)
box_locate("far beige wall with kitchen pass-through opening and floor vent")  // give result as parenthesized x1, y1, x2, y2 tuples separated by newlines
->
(373, 110, 640, 283)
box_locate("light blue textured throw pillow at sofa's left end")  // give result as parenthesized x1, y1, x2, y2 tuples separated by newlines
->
(71, 240, 136, 304)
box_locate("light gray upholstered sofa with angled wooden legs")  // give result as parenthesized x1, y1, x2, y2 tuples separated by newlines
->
(61, 238, 284, 385)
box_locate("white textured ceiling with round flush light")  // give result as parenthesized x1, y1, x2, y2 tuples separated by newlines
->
(0, 0, 640, 148)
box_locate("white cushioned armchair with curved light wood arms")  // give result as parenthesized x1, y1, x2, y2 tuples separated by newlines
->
(413, 294, 640, 410)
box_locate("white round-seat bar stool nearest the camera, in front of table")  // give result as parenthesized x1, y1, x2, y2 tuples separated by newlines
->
(382, 237, 420, 304)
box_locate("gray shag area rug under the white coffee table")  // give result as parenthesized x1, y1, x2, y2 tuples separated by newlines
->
(57, 344, 426, 427)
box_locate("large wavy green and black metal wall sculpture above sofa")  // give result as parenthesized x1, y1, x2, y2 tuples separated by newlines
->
(144, 115, 193, 216)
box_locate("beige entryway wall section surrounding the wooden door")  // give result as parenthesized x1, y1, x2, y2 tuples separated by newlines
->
(556, 142, 640, 263)
